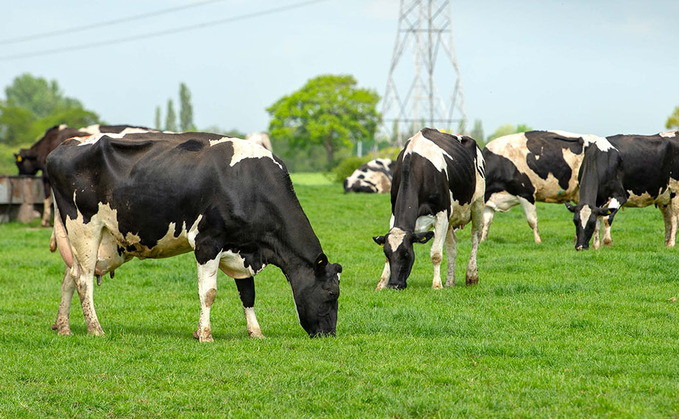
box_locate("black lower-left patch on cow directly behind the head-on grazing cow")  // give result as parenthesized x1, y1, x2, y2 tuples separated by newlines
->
(483, 148, 535, 204)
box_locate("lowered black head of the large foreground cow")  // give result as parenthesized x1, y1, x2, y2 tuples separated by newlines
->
(295, 253, 342, 338)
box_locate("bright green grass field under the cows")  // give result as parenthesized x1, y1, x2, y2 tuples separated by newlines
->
(0, 175, 679, 418)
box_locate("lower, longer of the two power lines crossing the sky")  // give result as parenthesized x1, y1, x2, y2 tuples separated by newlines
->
(0, 0, 327, 61)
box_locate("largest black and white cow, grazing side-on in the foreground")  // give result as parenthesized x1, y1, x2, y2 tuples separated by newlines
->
(47, 132, 342, 342)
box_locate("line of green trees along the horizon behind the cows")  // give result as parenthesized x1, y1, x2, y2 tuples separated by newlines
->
(0, 73, 679, 175)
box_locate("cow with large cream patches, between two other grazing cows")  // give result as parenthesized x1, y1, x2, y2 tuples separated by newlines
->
(481, 131, 595, 243)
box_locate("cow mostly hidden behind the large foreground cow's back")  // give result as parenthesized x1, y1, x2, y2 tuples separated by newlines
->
(14, 124, 154, 227)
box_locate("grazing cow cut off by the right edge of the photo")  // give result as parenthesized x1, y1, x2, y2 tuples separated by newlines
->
(566, 132, 679, 250)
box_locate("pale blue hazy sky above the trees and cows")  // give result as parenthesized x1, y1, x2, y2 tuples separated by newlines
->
(0, 0, 679, 141)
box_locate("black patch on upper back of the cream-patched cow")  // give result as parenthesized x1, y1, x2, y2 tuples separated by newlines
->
(524, 131, 583, 190)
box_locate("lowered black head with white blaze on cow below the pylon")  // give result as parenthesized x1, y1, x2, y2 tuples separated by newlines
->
(373, 227, 434, 289)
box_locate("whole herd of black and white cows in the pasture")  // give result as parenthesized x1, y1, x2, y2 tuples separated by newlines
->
(15, 125, 679, 342)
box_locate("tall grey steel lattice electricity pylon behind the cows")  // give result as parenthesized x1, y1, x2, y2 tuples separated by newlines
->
(382, 0, 467, 145)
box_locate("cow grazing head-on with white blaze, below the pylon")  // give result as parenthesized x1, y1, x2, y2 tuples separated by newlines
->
(373, 128, 485, 289)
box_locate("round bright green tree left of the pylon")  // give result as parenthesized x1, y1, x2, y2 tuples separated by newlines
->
(267, 75, 381, 168)
